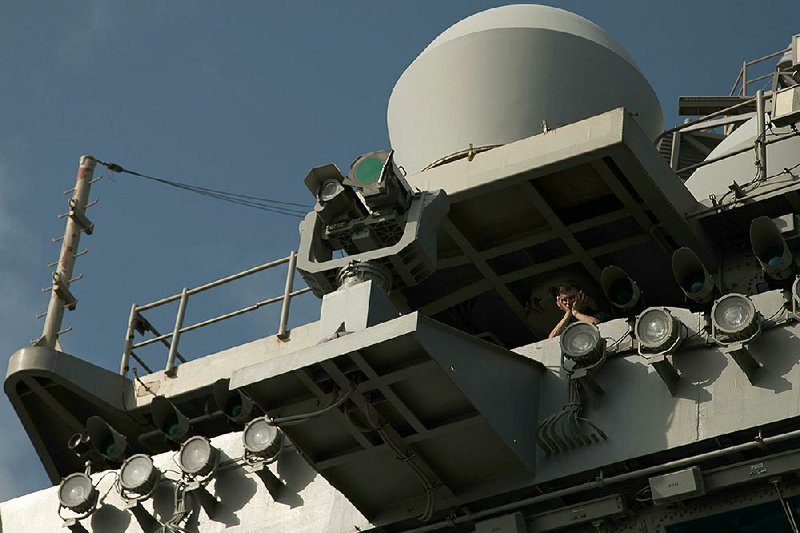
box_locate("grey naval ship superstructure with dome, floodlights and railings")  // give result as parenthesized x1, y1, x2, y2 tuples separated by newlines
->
(0, 5, 800, 533)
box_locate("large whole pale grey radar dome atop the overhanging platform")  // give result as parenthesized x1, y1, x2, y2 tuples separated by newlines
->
(387, 4, 663, 174)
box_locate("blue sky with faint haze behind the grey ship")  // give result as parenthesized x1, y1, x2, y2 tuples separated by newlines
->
(0, 0, 800, 501)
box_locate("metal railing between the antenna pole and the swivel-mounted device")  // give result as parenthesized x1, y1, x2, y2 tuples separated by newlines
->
(119, 251, 311, 376)
